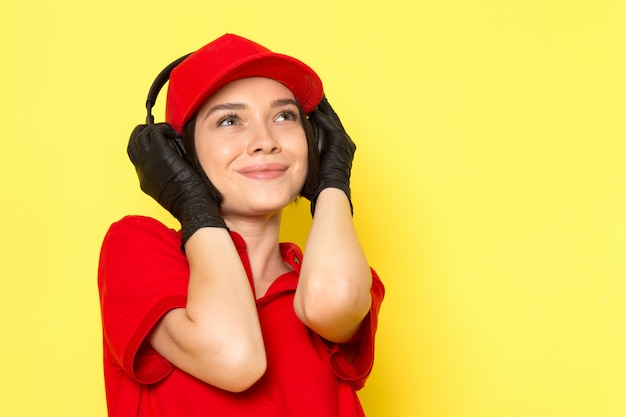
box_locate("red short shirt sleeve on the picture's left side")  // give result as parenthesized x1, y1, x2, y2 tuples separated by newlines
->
(98, 216, 189, 384)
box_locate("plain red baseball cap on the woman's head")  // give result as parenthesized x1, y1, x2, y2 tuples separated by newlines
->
(165, 34, 324, 132)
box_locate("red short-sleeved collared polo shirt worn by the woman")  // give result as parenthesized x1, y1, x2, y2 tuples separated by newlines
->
(98, 216, 384, 417)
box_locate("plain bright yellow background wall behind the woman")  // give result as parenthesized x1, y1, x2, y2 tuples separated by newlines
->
(0, 0, 626, 417)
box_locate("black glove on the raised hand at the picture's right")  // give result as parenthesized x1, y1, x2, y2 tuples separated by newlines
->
(307, 96, 356, 214)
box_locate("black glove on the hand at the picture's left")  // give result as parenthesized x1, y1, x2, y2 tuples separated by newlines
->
(128, 123, 227, 246)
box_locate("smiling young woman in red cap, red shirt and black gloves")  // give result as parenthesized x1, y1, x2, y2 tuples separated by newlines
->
(98, 34, 384, 417)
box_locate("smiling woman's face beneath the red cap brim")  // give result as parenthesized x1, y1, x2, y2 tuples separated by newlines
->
(195, 78, 308, 216)
